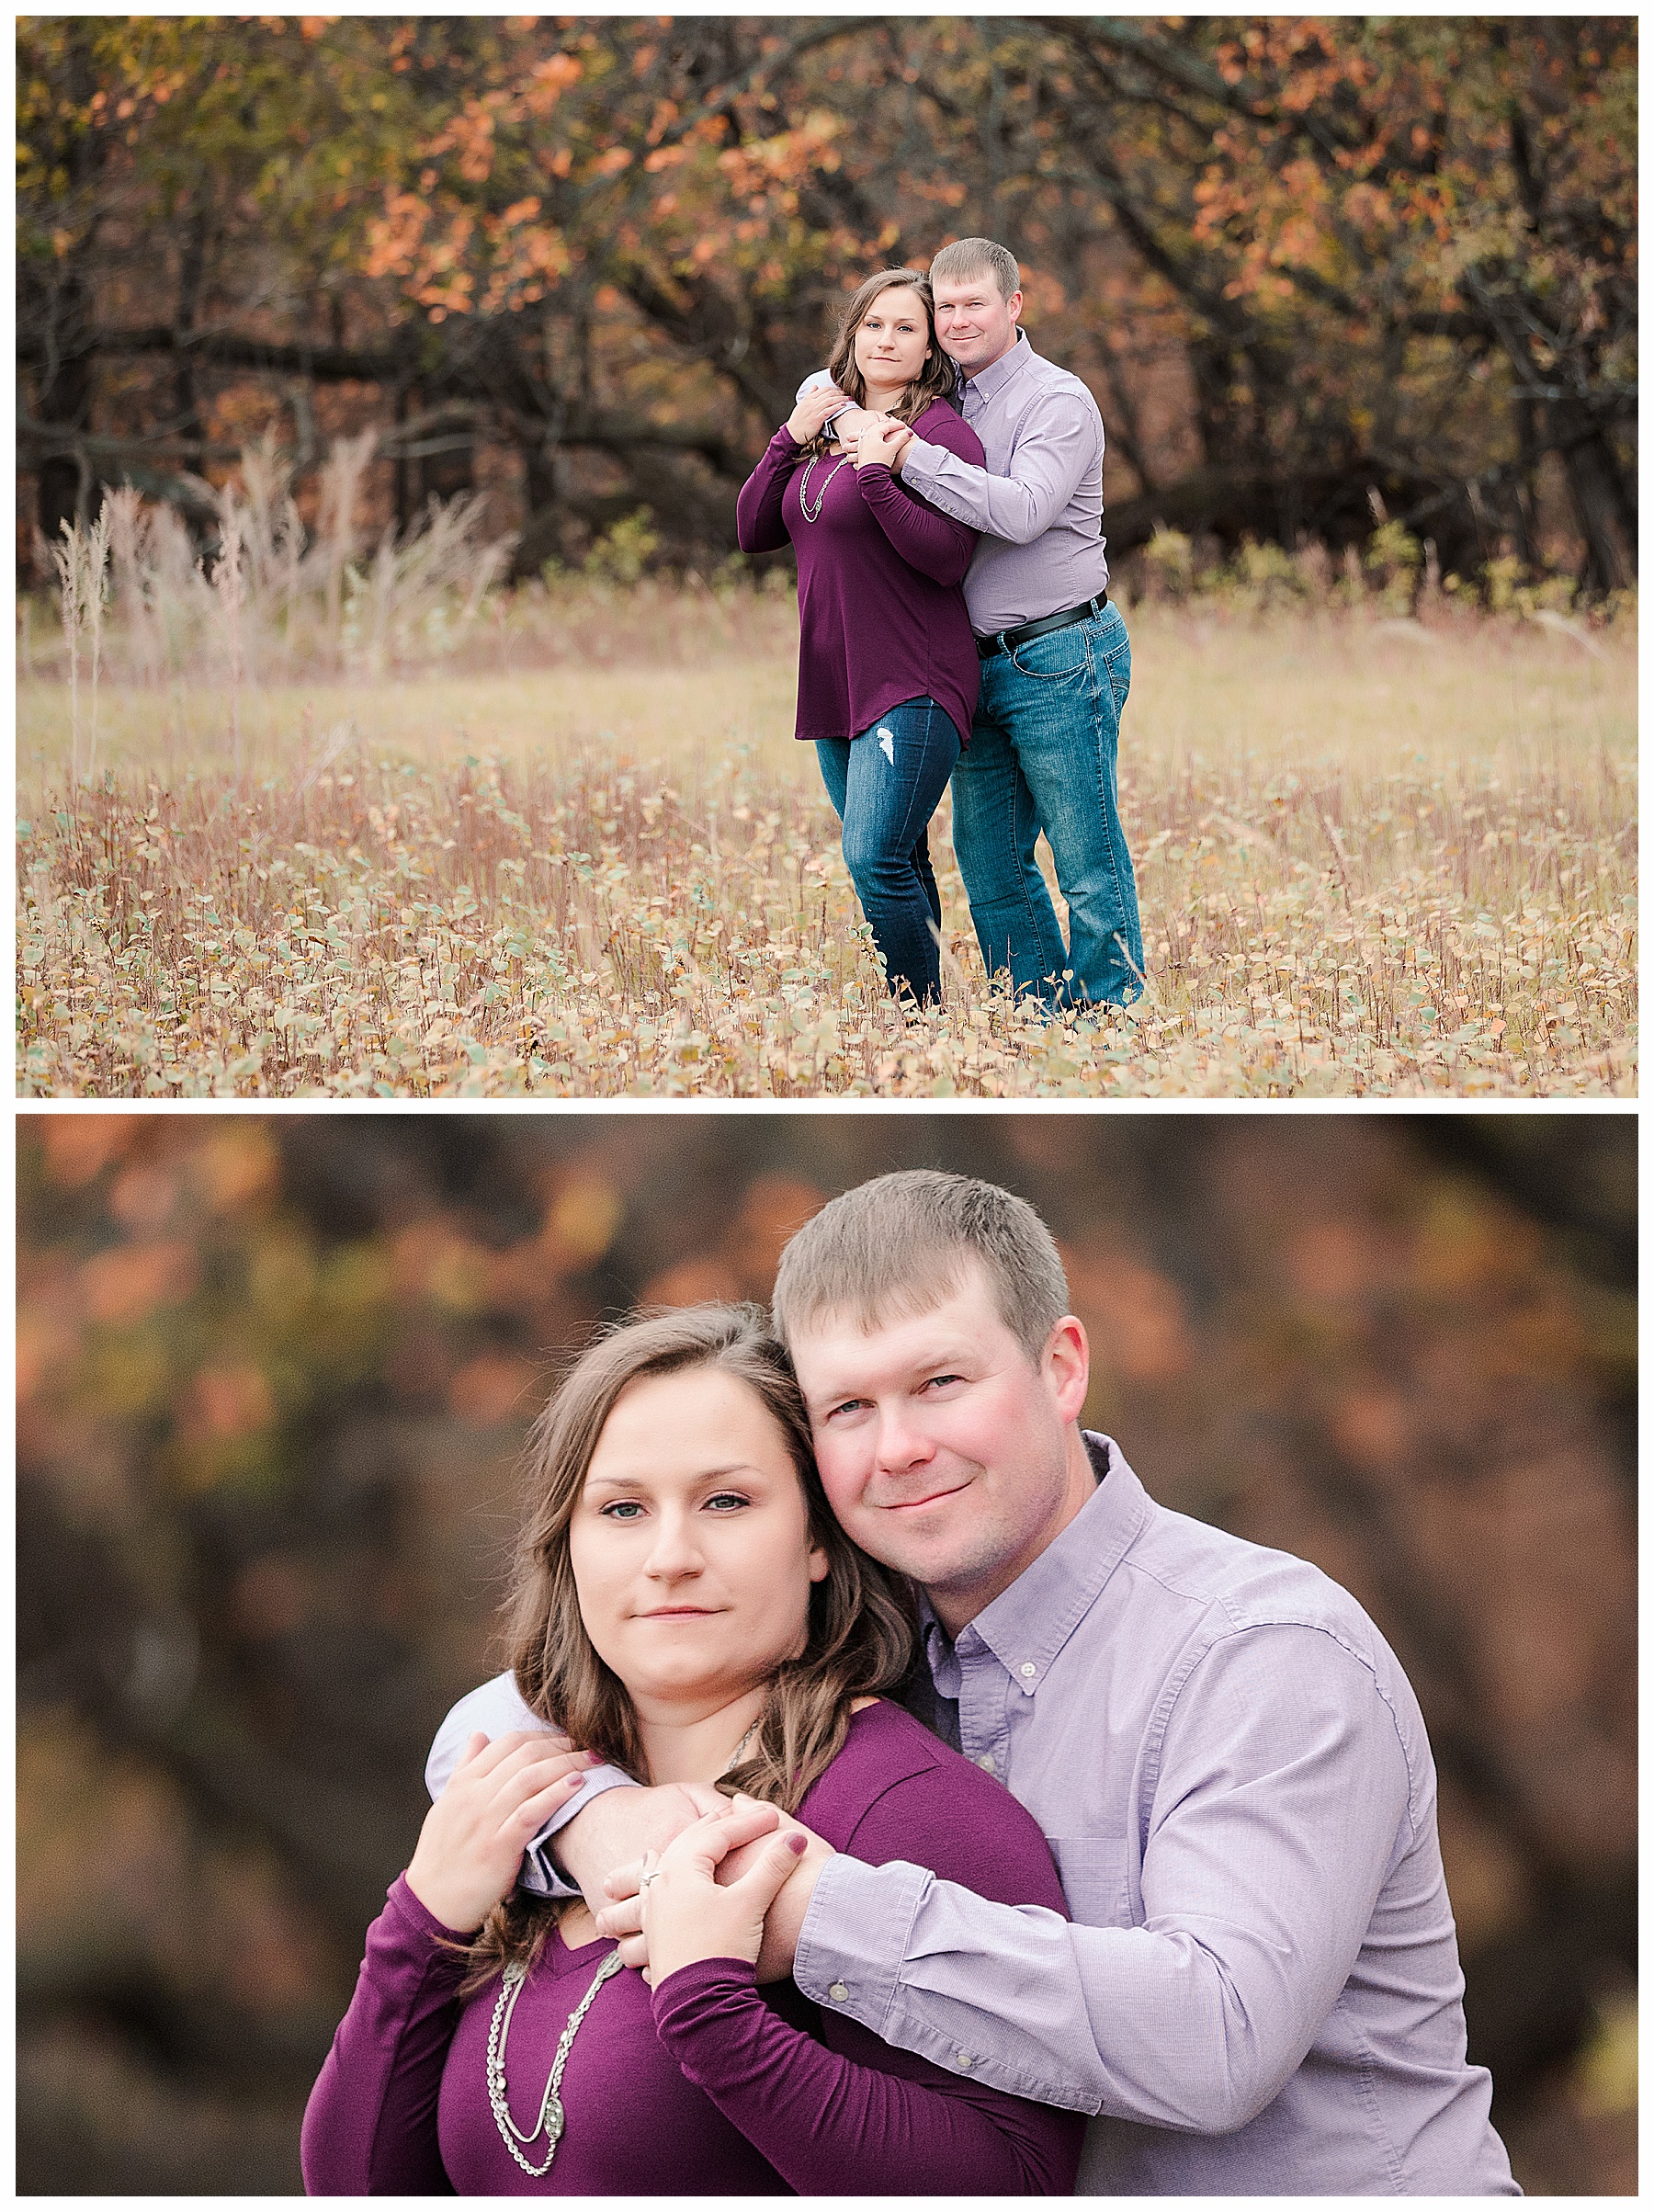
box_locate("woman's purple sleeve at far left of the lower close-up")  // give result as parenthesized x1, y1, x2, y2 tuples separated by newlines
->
(299, 1874, 464, 2196)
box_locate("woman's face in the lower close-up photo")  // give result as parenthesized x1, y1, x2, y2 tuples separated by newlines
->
(568, 1367, 827, 1721)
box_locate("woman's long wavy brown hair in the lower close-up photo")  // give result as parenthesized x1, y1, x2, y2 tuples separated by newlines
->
(467, 1305, 915, 1991)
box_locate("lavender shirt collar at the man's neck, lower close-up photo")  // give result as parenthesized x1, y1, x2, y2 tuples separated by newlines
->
(920, 1424, 1148, 1696)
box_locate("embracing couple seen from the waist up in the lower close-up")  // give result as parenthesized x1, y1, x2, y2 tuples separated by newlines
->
(303, 1173, 1514, 2196)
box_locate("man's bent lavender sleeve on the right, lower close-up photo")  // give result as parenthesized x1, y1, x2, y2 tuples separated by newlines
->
(794, 1624, 1413, 2135)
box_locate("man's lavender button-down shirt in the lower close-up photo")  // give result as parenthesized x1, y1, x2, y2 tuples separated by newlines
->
(794, 1433, 1519, 2196)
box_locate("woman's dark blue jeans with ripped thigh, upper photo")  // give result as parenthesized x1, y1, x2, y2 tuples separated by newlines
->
(816, 699, 959, 1006)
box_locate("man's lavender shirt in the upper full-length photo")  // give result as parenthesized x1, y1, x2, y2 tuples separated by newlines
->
(902, 330, 1108, 637)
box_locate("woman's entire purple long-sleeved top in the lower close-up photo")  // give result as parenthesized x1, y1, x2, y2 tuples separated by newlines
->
(303, 1703, 1082, 2196)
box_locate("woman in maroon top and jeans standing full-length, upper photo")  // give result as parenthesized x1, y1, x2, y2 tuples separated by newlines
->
(736, 270, 984, 1004)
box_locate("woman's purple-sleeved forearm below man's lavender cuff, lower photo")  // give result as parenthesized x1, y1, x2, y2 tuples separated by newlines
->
(654, 1960, 1079, 2196)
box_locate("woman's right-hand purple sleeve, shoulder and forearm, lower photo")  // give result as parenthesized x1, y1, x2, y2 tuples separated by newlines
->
(654, 1761, 1083, 2196)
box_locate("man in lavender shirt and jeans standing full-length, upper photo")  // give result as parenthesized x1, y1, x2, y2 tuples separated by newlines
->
(811, 239, 1143, 1006)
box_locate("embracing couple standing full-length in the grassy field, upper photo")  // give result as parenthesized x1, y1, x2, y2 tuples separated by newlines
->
(736, 239, 1143, 1009)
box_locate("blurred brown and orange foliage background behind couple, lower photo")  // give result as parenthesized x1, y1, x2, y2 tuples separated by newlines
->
(17, 1113, 1637, 2195)
